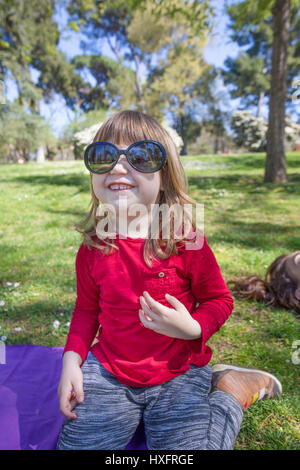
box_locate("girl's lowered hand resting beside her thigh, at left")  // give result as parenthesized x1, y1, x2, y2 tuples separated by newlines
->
(57, 351, 84, 419)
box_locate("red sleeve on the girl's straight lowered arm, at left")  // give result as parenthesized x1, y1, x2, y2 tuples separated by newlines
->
(63, 244, 100, 363)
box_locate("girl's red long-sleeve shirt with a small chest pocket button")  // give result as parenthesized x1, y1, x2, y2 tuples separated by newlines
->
(64, 235, 233, 387)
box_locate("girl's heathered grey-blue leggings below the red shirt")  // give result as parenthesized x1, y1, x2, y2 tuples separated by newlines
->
(57, 352, 243, 450)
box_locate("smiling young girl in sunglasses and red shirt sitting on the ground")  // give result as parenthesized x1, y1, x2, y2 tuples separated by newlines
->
(57, 111, 281, 450)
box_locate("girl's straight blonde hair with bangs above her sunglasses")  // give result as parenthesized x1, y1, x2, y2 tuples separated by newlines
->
(75, 110, 197, 267)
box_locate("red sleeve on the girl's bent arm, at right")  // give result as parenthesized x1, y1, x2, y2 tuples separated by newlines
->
(188, 234, 234, 354)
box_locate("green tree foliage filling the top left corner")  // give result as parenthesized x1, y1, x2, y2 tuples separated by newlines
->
(0, 0, 84, 112)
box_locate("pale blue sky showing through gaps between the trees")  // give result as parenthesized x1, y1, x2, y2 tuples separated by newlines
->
(6, 0, 247, 136)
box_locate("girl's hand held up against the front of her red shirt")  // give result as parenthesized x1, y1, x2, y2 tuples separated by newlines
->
(139, 292, 202, 339)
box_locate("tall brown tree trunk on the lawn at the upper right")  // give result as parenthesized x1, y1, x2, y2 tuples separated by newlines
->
(264, 0, 290, 182)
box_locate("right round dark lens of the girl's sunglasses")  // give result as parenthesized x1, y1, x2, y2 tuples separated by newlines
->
(128, 142, 164, 173)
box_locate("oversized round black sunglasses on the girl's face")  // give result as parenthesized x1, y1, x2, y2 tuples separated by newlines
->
(84, 140, 167, 174)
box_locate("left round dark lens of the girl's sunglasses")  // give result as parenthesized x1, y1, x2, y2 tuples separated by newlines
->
(85, 143, 118, 173)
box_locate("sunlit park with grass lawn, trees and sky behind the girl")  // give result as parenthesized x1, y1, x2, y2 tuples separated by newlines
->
(0, 0, 300, 449)
